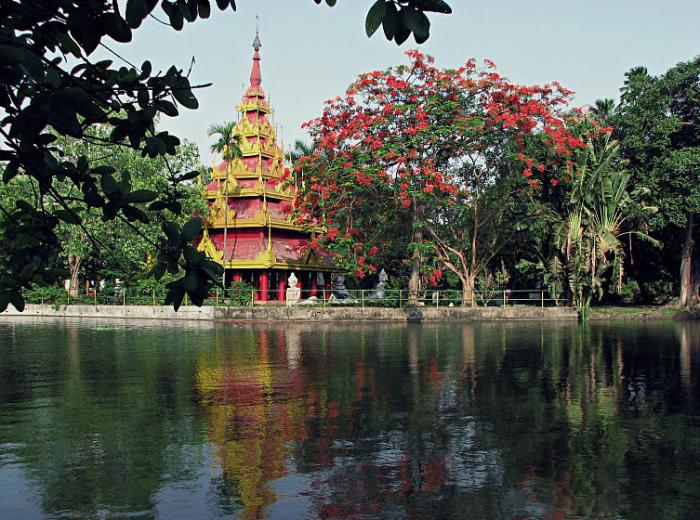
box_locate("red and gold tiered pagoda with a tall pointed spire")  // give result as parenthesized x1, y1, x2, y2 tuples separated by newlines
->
(198, 34, 339, 302)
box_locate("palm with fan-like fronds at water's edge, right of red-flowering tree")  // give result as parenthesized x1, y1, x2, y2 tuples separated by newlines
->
(556, 136, 659, 318)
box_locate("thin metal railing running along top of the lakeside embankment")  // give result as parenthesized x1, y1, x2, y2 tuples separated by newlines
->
(26, 287, 568, 308)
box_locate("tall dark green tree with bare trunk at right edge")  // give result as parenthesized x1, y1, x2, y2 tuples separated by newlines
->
(614, 58, 700, 306)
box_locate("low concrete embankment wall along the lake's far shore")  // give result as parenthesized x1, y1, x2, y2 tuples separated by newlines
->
(0, 304, 578, 322)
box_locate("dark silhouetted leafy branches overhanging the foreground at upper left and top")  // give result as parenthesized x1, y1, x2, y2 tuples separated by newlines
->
(0, 0, 449, 310)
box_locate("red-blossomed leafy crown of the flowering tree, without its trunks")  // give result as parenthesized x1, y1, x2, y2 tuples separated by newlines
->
(297, 51, 612, 274)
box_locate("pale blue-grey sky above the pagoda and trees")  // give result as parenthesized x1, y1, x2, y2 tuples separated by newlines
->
(103, 0, 700, 164)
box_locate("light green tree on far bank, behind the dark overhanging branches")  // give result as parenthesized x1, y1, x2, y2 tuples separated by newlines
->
(0, 127, 205, 297)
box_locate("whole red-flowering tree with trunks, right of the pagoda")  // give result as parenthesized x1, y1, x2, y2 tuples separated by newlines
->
(297, 51, 608, 303)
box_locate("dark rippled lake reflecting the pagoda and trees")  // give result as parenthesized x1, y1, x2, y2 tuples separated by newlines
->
(0, 318, 700, 519)
